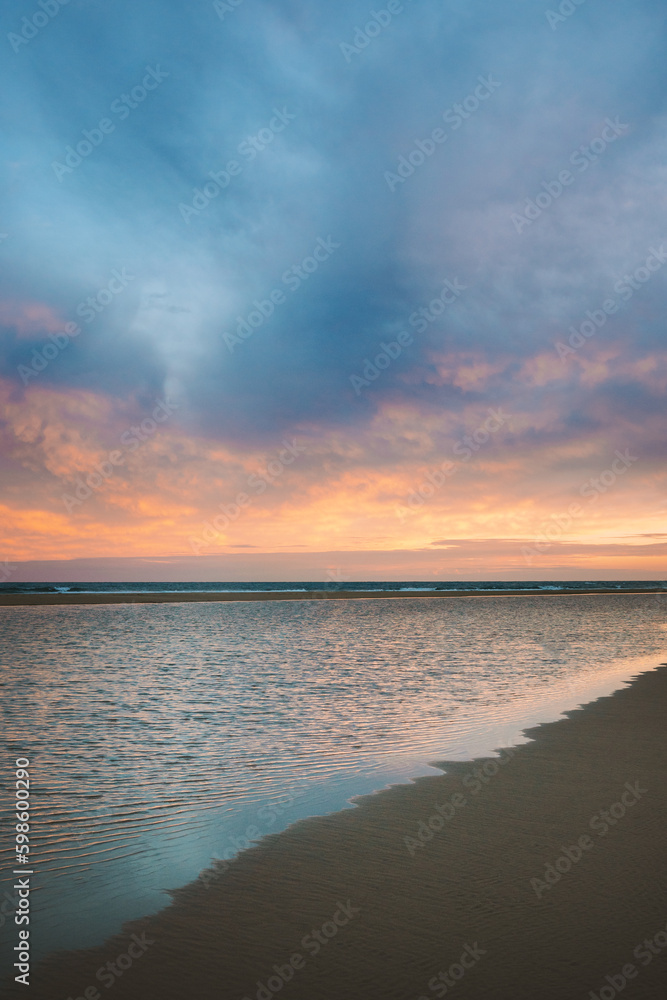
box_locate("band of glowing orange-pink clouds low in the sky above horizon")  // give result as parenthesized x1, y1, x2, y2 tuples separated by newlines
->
(0, 384, 667, 578)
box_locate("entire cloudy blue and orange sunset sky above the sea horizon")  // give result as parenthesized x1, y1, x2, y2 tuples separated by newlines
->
(0, 0, 667, 581)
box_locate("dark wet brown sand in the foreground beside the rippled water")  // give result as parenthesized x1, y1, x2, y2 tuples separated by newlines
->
(11, 666, 667, 1000)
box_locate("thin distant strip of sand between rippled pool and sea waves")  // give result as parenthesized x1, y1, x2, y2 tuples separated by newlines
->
(0, 587, 667, 607)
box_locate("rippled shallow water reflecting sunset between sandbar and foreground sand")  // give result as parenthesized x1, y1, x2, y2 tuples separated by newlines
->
(0, 593, 667, 974)
